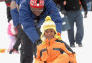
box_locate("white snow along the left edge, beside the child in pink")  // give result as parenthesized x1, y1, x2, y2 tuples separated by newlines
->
(0, 2, 20, 63)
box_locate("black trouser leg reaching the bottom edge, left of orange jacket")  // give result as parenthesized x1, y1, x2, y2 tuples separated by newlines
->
(20, 32, 33, 63)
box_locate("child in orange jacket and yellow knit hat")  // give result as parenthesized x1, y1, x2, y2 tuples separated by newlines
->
(35, 16, 76, 63)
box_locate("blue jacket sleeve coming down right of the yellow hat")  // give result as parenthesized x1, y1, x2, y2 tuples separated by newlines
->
(45, 0, 62, 32)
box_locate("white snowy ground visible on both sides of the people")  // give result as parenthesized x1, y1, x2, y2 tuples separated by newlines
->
(0, 2, 92, 63)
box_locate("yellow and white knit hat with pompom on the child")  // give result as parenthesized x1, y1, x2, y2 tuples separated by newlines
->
(40, 16, 57, 41)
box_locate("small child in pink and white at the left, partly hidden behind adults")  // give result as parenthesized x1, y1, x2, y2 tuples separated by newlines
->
(8, 20, 17, 52)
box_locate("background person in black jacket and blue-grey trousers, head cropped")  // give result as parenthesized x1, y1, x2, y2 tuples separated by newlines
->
(61, 0, 87, 47)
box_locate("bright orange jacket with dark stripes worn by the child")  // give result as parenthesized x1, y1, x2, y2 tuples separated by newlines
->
(36, 38, 72, 63)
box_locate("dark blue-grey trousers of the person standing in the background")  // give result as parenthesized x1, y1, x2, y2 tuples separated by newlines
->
(67, 11, 84, 43)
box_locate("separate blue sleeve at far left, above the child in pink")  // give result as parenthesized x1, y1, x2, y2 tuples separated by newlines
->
(10, 8, 19, 27)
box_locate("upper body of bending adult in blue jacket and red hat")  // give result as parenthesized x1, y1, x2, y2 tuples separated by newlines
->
(19, 0, 62, 43)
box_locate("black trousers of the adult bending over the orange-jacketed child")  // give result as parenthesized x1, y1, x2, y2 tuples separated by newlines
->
(17, 27, 33, 63)
